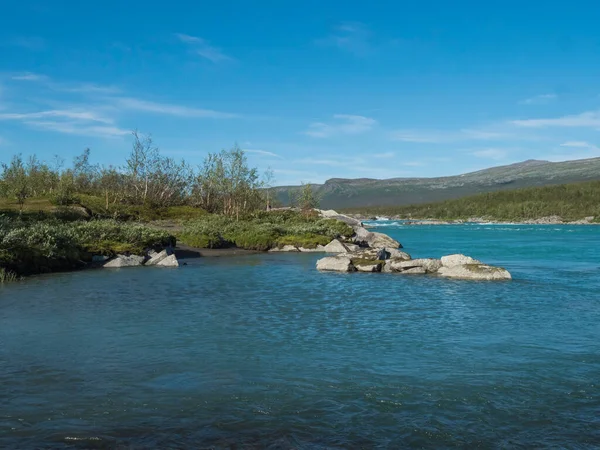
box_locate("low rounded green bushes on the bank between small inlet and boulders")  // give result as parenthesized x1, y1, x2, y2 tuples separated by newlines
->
(178, 211, 354, 250)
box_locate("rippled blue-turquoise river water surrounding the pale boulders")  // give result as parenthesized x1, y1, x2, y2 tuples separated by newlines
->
(0, 225, 600, 449)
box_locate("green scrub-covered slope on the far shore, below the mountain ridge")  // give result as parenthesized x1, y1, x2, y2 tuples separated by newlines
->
(346, 181, 600, 221)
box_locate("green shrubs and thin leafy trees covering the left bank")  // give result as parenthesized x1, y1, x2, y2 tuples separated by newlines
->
(0, 132, 328, 282)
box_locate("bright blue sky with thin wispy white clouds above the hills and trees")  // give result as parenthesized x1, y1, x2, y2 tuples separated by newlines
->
(0, 0, 600, 184)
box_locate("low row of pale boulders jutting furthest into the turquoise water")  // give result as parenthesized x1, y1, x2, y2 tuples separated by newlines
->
(317, 248, 512, 280)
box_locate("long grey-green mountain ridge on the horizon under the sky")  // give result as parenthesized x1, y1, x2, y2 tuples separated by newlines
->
(274, 158, 600, 209)
